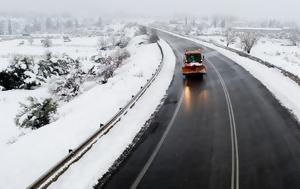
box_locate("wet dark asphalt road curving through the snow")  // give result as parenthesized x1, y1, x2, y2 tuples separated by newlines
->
(95, 32, 300, 189)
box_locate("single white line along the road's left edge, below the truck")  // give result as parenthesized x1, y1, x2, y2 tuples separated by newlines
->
(130, 92, 183, 189)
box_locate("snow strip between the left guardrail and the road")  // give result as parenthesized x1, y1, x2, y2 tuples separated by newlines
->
(50, 41, 175, 189)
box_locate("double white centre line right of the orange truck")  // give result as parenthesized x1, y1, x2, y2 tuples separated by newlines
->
(207, 61, 239, 189)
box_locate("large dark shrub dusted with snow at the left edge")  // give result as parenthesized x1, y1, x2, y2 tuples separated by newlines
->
(0, 55, 44, 90)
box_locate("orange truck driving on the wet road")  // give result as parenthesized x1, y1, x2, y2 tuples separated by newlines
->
(182, 49, 206, 76)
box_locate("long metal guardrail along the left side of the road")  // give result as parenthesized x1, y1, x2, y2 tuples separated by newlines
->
(27, 42, 164, 189)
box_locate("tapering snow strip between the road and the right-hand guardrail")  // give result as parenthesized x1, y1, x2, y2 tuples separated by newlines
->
(161, 28, 300, 124)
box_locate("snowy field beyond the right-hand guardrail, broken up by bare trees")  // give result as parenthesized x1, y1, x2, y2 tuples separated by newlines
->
(197, 35, 300, 77)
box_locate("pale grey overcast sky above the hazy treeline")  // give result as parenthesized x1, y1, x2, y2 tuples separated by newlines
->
(0, 0, 300, 23)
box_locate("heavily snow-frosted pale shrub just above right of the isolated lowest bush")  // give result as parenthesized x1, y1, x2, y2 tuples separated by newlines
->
(49, 71, 83, 102)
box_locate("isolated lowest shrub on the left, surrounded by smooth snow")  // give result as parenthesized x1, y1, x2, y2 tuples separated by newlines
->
(15, 97, 58, 129)
